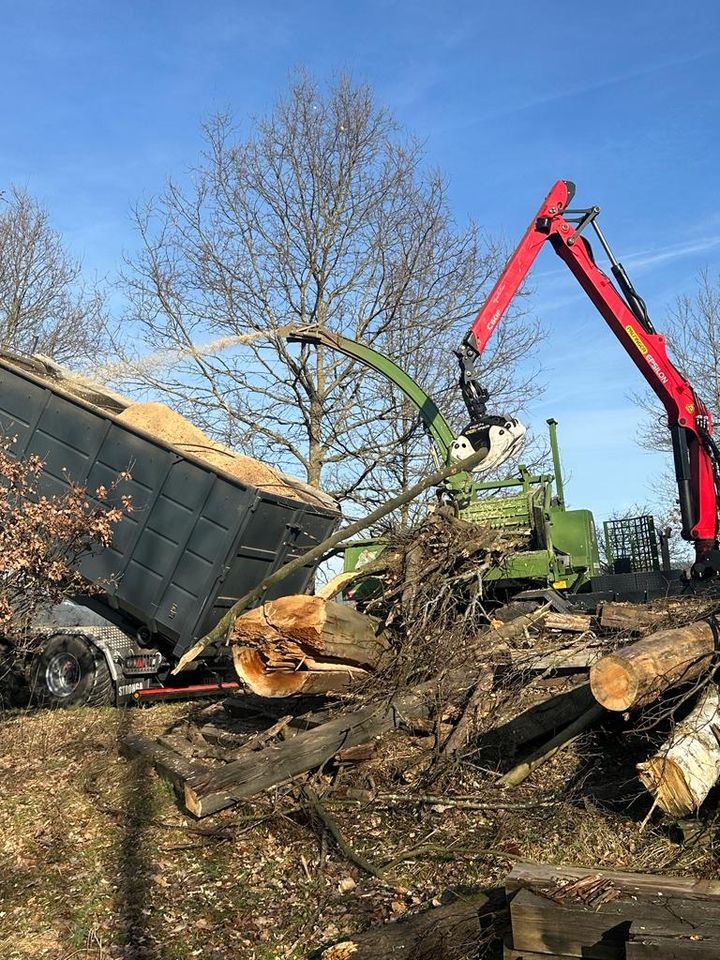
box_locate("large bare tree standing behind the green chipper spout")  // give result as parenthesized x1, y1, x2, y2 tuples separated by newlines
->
(125, 73, 539, 503)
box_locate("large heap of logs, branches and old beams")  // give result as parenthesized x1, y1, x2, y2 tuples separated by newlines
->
(114, 488, 720, 960)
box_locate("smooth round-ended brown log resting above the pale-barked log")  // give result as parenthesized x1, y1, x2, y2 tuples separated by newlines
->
(590, 620, 715, 710)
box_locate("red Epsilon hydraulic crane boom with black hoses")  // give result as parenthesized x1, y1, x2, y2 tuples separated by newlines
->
(457, 180, 720, 575)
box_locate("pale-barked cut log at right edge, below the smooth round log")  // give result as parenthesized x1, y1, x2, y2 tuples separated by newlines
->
(638, 684, 720, 817)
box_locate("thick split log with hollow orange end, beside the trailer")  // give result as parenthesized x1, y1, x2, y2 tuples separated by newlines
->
(229, 596, 389, 697)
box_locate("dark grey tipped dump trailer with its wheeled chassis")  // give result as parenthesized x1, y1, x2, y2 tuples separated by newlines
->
(0, 355, 340, 706)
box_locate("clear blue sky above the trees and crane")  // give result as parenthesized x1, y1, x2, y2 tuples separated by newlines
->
(0, 0, 720, 518)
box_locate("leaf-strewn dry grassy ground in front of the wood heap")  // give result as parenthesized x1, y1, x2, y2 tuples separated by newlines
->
(0, 704, 718, 960)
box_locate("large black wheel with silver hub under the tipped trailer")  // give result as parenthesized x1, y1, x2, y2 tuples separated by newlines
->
(32, 633, 115, 707)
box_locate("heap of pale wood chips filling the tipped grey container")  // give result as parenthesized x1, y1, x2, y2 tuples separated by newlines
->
(117, 403, 328, 506)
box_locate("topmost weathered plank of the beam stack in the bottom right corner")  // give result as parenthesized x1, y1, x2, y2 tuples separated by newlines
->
(505, 861, 720, 909)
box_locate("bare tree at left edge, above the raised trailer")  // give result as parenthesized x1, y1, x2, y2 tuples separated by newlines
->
(0, 186, 105, 364)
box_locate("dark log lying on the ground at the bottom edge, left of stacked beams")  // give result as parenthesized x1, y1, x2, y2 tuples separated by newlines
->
(312, 894, 504, 960)
